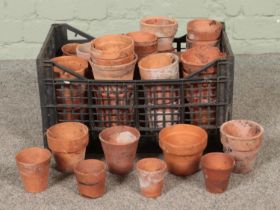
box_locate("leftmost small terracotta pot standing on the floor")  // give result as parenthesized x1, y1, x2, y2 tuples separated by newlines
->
(16, 147, 51, 193)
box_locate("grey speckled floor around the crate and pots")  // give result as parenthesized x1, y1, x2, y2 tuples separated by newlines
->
(0, 54, 280, 210)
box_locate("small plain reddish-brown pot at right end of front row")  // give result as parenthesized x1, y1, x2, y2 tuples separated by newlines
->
(201, 152, 234, 193)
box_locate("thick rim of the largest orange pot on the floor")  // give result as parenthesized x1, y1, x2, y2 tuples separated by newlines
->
(159, 124, 208, 149)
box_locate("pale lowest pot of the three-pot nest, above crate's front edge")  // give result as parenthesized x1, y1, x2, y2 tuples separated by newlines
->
(90, 55, 138, 80)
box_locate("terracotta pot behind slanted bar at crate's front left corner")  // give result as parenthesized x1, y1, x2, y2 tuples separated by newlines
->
(51, 56, 88, 79)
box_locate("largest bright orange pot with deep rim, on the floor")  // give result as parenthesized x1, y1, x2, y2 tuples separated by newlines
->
(159, 124, 208, 176)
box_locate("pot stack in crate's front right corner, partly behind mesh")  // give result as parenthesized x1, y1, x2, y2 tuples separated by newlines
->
(181, 46, 224, 125)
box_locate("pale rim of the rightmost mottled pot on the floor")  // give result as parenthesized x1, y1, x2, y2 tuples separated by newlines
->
(220, 119, 264, 141)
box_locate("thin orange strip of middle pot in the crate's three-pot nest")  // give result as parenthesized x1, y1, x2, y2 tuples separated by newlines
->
(91, 54, 135, 66)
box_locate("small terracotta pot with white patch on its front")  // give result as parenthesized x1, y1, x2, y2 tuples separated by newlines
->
(136, 158, 167, 198)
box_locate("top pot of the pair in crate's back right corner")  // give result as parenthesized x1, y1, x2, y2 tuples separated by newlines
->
(187, 19, 222, 41)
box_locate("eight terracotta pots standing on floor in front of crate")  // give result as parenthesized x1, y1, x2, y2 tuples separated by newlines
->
(16, 120, 264, 197)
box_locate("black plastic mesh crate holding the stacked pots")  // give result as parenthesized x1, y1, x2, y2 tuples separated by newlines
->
(37, 24, 234, 153)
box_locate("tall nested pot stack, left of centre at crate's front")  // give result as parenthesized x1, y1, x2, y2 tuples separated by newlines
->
(90, 34, 137, 126)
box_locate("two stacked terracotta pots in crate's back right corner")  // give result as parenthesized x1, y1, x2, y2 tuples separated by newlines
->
(186, 19, 222, 47)
